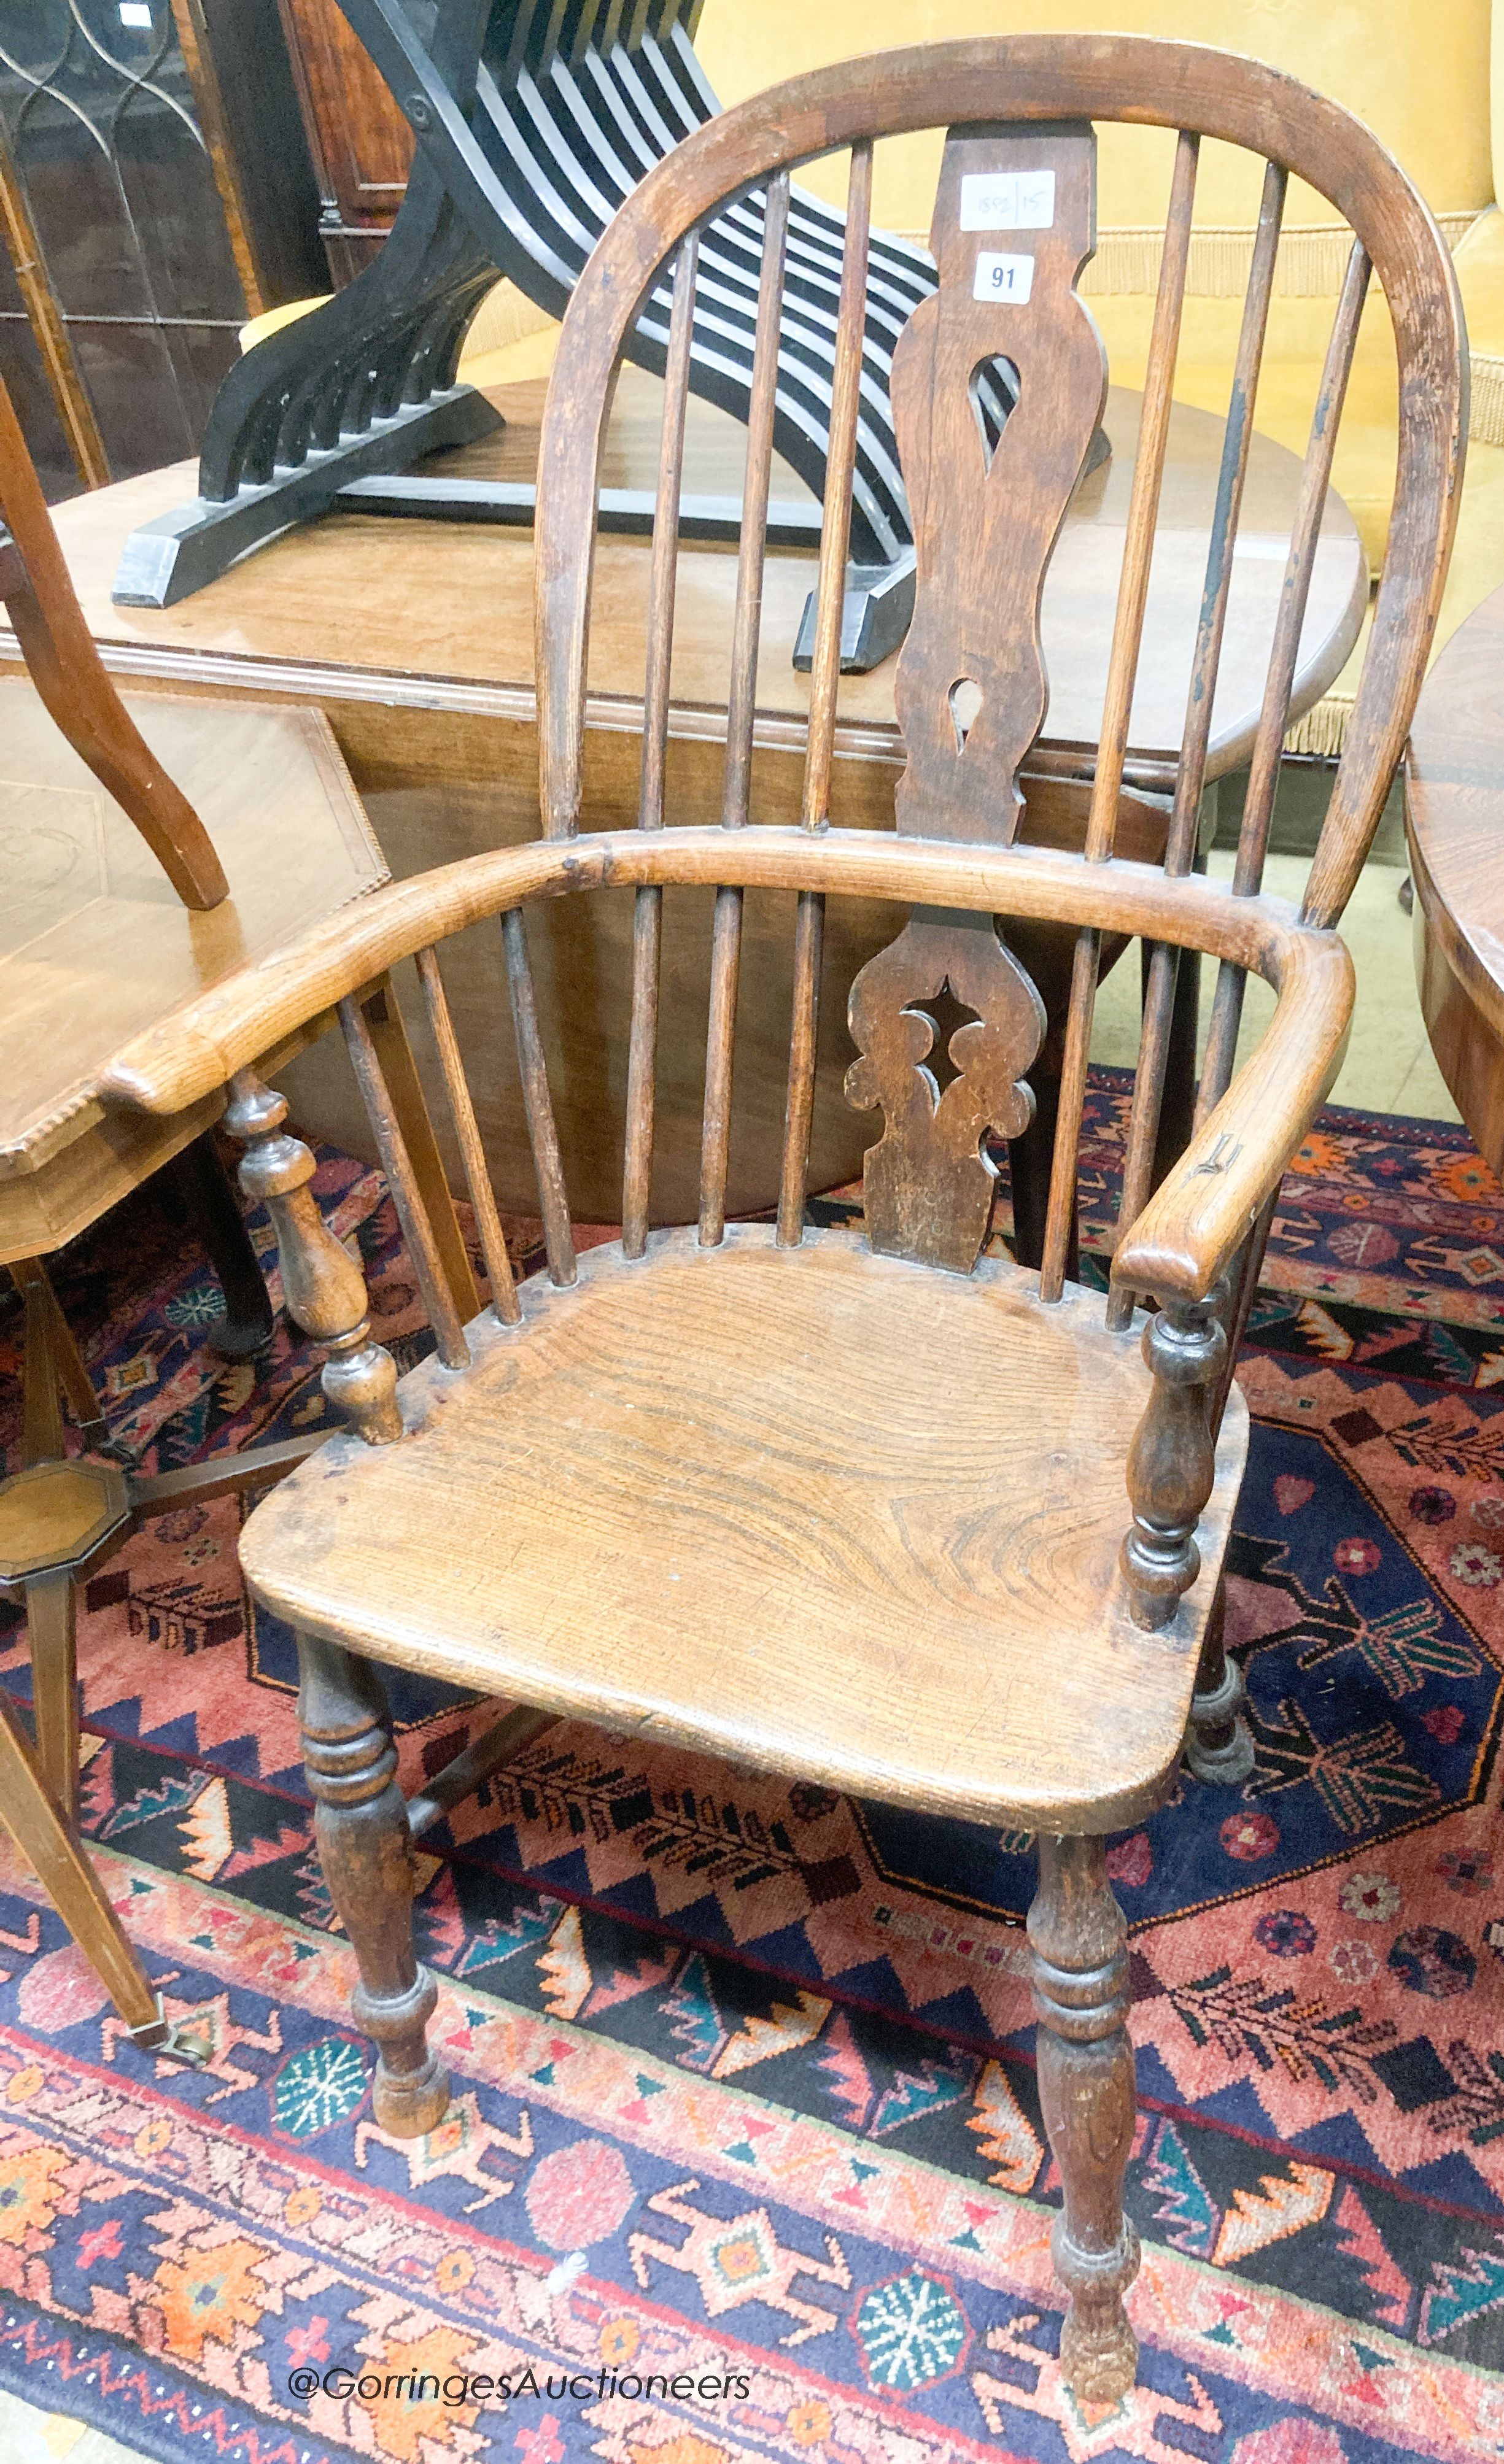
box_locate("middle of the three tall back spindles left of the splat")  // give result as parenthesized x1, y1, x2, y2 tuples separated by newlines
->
(700, 170, 789, 1249)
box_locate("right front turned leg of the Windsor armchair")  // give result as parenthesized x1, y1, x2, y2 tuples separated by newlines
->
(1028, 1831, 1139, 2403)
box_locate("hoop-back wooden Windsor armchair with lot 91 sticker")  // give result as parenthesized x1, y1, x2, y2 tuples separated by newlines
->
(99, 37, 1465, 2398)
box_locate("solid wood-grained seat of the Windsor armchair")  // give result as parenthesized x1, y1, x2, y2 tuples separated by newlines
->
(242, 1224, 1247, 1831)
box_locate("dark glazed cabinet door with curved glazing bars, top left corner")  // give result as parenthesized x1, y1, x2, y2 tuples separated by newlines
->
(0, 0, 316, 495)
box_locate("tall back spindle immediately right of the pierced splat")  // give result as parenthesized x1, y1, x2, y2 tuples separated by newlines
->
(1041, 128, 1201, 1301)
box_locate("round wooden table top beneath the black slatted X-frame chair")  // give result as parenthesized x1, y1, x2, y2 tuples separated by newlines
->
(38, 367, 1368, 779)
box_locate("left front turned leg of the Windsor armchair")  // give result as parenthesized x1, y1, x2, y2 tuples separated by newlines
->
(298, 1634, 449, 2139)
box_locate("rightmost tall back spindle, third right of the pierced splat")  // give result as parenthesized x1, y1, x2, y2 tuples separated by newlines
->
(1196, 241, 1371, 1121)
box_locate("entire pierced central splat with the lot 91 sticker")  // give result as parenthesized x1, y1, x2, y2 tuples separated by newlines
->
(846, 121, 1107, 1274)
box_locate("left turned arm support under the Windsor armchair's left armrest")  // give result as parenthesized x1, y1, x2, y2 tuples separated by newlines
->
(224, 1070, 402, 1446)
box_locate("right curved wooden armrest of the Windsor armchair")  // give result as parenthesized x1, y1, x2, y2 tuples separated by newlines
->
(1112, 929, 1354, 1301)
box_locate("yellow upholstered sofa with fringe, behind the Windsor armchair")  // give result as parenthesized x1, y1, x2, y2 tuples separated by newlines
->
(257, 0, 1504, 754)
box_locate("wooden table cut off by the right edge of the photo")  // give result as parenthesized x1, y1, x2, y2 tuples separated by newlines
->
(1405, 589, 1504, 1173)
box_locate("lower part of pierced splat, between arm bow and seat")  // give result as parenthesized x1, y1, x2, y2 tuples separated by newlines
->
(846, 910, 1045, 1274)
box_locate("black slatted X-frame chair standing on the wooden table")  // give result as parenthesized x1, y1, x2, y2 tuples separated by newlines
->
(114, 0, 1040, 668)
